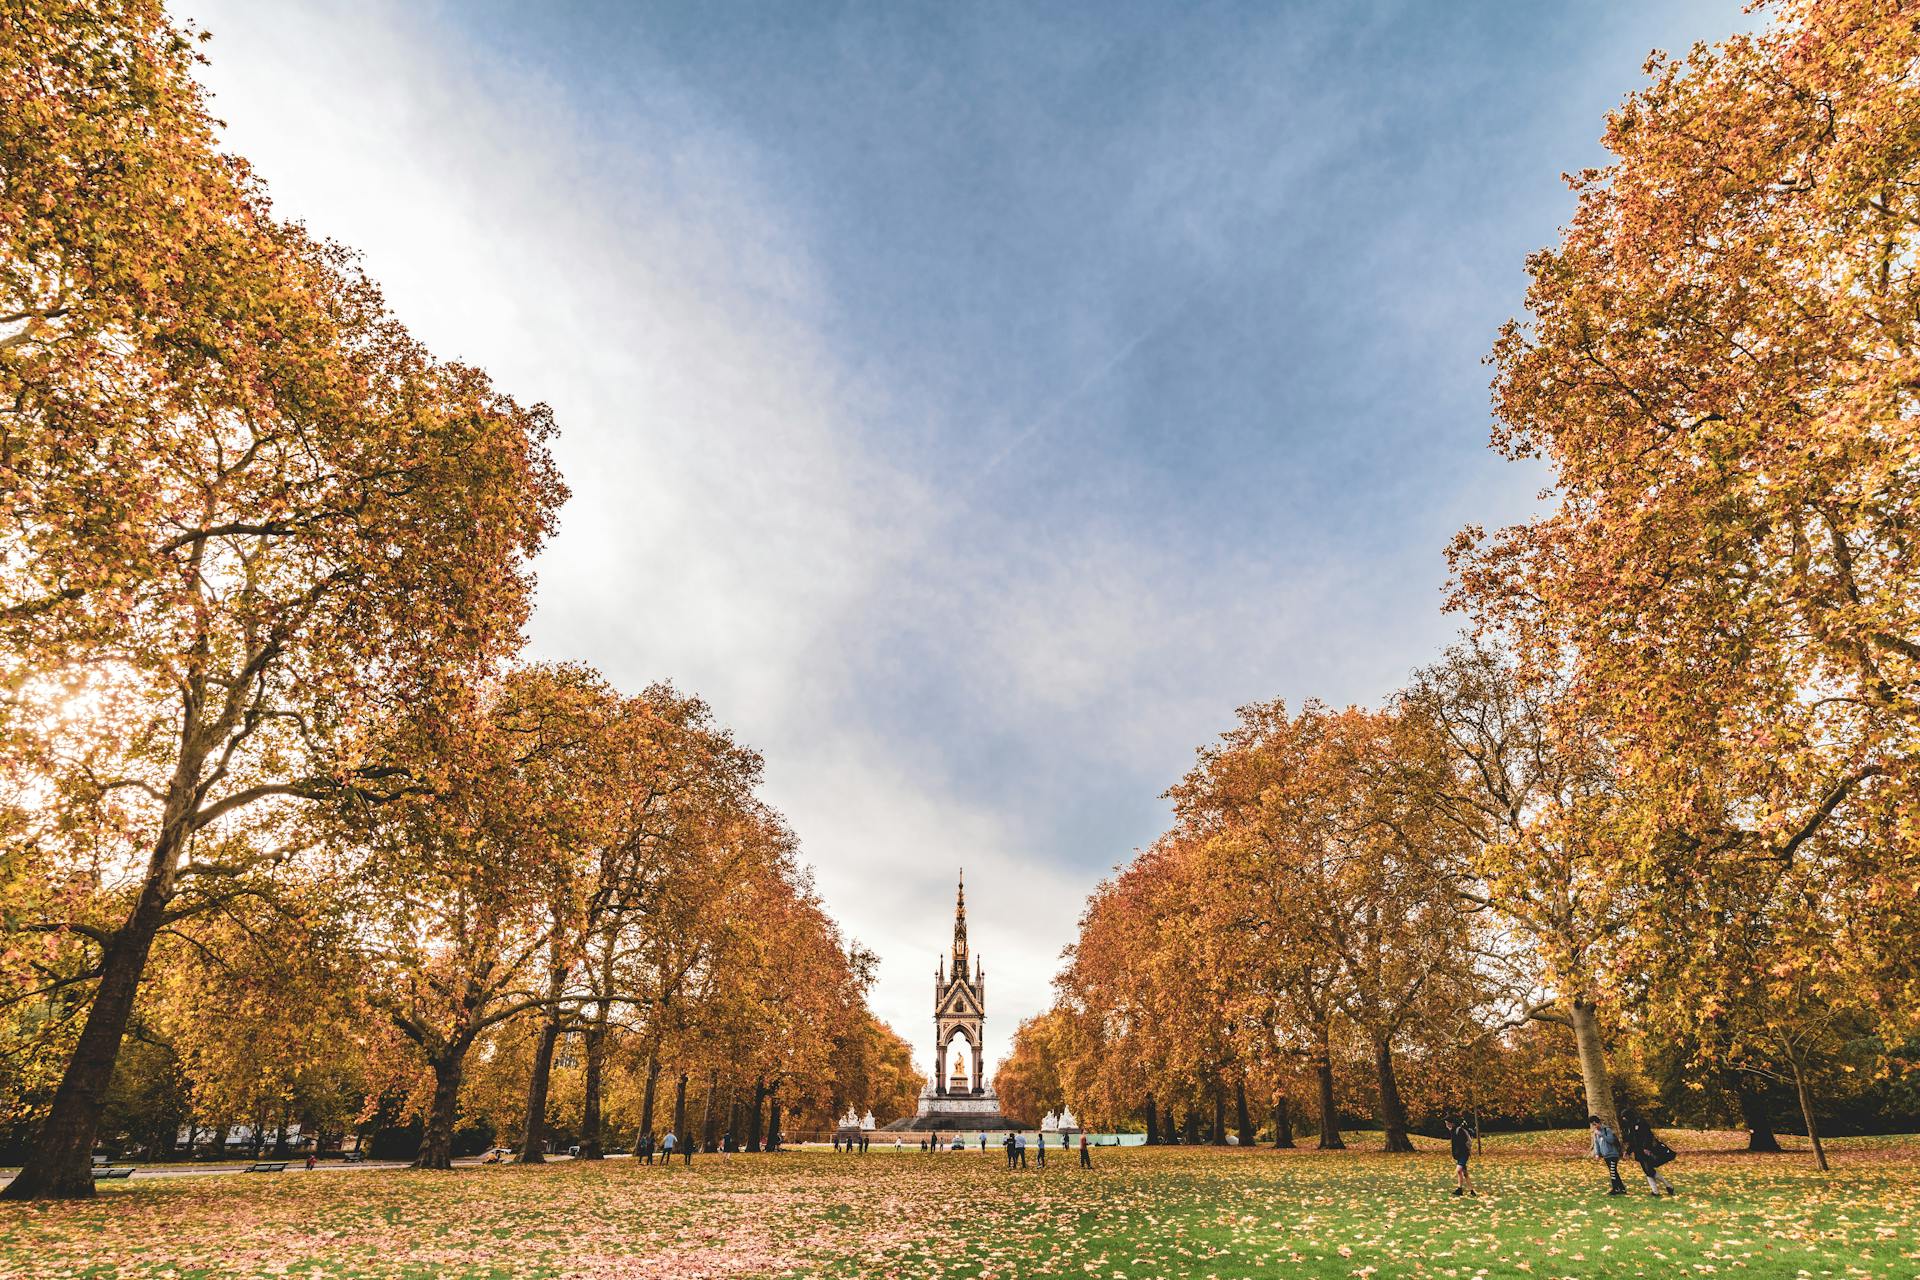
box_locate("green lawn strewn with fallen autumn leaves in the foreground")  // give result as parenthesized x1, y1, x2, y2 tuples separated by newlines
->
(0, 1134, 1920, 1280)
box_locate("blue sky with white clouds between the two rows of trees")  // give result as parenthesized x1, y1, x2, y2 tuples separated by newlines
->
(177, 0, 1751, 1057)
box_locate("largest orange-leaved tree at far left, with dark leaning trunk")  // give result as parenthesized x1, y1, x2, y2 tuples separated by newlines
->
(0, 0, 563, 1199)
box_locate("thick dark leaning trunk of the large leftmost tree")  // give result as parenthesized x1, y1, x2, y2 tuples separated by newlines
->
(0, 782, 192, 1199)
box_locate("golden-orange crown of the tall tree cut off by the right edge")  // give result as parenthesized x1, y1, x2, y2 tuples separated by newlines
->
(1453, 0, 1920, 1051)
